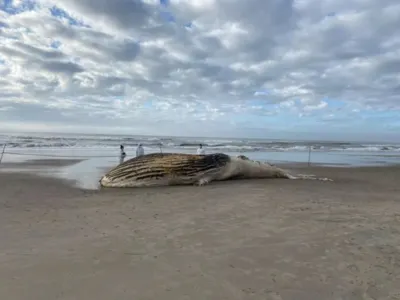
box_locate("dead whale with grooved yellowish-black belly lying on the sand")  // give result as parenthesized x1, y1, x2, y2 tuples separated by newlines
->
(99, 153, 329, 187)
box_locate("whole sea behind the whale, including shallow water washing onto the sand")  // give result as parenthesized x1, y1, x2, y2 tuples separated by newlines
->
(0, 133, 400, 189)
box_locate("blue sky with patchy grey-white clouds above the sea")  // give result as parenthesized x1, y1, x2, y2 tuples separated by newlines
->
(0, 0, 400, 140)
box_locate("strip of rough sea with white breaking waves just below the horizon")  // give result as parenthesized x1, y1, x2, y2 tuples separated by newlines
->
(0, 134, 400, 152)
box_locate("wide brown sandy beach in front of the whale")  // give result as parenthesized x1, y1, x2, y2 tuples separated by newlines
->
(0, 162, 400, 300)
